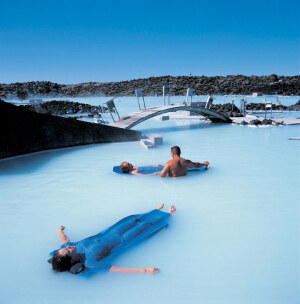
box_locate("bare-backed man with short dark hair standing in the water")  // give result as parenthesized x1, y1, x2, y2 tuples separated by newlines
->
(157, 146, 209, 177)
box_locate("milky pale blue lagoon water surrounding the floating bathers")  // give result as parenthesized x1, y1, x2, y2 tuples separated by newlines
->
(0, 98, 300, 304)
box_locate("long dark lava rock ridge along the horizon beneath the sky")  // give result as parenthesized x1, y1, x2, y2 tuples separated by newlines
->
(0, 74, 300, 99)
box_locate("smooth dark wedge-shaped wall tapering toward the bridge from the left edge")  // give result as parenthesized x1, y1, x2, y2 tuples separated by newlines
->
(0, 100, 141, 162)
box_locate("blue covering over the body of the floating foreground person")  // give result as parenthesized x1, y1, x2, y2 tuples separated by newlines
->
(50, 209, 170, 270)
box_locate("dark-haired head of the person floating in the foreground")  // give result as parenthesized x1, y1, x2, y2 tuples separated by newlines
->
(52, 246, 79, 272)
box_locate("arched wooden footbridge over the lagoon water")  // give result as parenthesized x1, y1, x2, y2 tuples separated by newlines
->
(110, 105, 232, 129)
